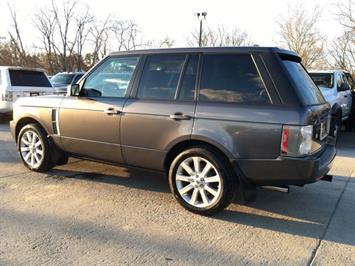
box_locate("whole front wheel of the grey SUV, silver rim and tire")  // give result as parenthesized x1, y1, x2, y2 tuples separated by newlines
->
(17, 124, 53, 172)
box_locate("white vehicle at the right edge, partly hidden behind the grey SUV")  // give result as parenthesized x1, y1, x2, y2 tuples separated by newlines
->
(310, 70, 352, 136)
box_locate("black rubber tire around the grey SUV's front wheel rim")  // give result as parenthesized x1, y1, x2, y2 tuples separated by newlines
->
(17, 124, 54, 172)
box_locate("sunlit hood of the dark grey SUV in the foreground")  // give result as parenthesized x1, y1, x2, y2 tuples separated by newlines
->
(14, 95, 64, 108)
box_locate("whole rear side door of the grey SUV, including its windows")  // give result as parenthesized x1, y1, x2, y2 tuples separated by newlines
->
(121, 54, 199, 170)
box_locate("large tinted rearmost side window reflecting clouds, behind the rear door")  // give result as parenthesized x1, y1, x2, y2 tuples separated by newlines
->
(200, 55, 270, 104)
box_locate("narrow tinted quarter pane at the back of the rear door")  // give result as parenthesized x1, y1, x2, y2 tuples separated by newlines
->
(178, 55, 198, 101)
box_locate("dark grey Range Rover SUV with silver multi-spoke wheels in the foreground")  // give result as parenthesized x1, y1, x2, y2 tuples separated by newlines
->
(10, 47, 336, 215)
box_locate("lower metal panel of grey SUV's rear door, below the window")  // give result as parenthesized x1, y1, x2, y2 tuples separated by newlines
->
(121, 99, 195, 170)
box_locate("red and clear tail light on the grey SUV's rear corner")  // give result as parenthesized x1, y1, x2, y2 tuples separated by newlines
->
(281, 125, 314, 156)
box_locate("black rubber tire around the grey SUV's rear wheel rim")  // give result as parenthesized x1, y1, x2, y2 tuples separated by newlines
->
(169, 146, 237, 215)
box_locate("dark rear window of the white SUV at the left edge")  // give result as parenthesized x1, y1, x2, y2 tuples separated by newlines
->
(9, 69, 52, 87)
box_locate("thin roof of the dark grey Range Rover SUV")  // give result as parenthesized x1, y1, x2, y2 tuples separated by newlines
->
(110, 46, 299, 57)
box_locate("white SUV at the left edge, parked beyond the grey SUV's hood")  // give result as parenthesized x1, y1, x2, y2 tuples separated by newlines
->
(0, 66, 53, 114)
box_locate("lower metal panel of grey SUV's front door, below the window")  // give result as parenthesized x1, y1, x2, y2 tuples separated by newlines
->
(58, 97, 125, 163)
